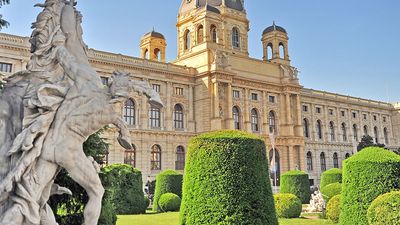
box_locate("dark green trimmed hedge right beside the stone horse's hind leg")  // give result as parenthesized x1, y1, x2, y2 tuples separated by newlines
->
(100, 164, 147, 215)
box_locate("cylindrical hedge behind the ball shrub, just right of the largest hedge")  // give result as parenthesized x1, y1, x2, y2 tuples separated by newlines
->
(280, 170, 311, 204)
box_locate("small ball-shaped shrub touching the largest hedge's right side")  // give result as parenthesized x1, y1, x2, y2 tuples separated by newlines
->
(274, 194, 302, 218)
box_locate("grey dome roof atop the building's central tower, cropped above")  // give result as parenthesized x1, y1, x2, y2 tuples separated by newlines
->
(179, 0, 244, 14)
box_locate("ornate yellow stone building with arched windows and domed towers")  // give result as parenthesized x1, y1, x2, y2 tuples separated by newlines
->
(0, 0, 400, 185)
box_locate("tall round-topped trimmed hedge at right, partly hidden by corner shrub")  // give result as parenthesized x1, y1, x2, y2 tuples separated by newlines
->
(340, 147, 400, 225)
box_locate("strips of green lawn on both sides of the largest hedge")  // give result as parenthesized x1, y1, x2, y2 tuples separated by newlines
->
(117, 213, 333, 225)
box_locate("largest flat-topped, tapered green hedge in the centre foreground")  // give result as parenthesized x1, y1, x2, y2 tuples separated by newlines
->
(179, 131, 278, 225)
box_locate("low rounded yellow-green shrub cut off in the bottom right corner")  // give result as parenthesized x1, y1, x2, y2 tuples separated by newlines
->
(368, 191, 400, 225)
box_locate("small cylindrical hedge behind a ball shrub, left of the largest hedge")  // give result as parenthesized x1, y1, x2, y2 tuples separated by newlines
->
(153, 170, 183, 211)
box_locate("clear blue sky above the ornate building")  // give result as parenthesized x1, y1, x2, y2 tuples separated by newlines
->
(0, 0, 400, 102)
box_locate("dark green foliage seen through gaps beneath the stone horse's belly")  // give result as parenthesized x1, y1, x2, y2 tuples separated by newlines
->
(49, 129, 108, 225)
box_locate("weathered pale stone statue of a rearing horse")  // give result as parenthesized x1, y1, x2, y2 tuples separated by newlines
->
(0, 0, 163, 225)
